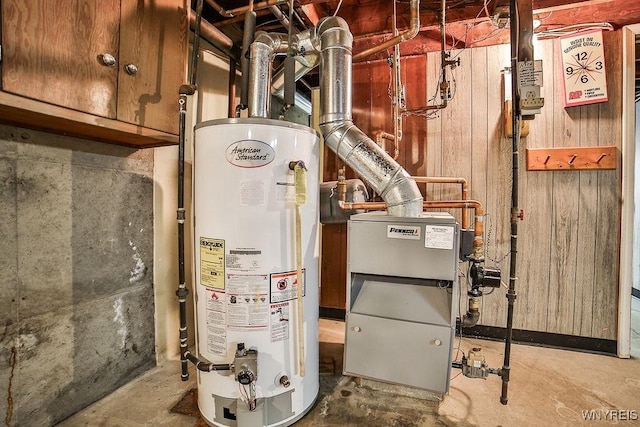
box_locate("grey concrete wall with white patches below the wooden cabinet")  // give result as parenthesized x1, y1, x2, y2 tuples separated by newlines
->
(0, 125, 155, 426)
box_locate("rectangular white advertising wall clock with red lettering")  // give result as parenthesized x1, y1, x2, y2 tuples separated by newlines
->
(560, 30, 608, 107)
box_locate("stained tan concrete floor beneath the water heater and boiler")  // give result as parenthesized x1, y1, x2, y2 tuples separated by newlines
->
(59, 308, 640, 427)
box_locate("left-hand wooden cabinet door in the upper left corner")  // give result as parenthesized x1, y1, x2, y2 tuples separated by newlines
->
(2, 0, 120, 118)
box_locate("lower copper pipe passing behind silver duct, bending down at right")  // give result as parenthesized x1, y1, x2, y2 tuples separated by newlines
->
(338, 200, 484, 261)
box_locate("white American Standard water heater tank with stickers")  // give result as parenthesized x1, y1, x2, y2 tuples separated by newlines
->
(194, 119, 319, 427)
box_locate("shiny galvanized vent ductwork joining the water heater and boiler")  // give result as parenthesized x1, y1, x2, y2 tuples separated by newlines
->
(249, 17, 423, 217)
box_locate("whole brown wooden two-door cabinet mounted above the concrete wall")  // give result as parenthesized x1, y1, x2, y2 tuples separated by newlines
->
(0, 0, 188, 146)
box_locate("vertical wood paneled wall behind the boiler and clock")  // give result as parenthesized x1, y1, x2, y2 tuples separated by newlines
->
(323, 31, 622, 339)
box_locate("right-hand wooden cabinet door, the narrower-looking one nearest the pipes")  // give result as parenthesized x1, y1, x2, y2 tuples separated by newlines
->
(118, 0, 189, 134)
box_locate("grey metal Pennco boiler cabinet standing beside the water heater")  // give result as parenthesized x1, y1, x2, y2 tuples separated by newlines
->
(344, 212, 460, 393)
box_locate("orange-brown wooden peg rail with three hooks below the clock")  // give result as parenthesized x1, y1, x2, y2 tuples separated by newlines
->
(527, 145, 617, 171)
